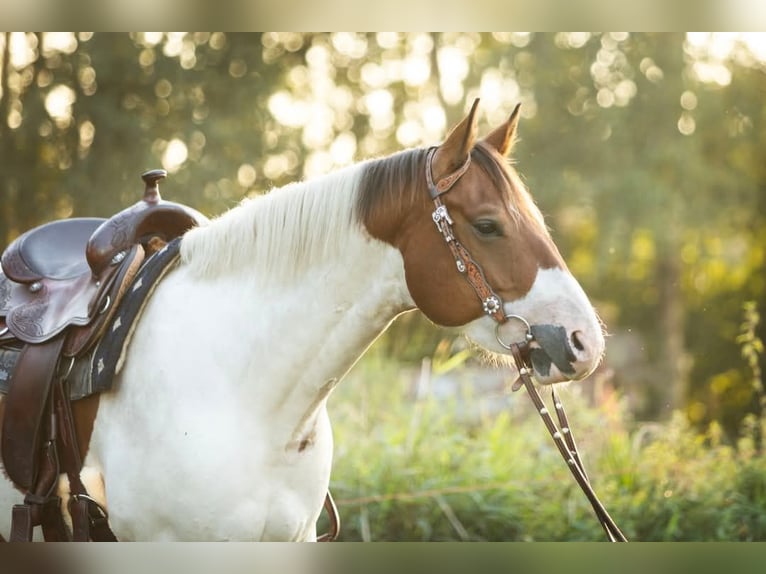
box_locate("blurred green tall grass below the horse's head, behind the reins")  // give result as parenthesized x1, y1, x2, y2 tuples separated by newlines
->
(320, 342, 766, 541)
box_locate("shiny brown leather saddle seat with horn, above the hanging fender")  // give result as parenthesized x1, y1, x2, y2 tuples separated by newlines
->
(0, 166, 207, 346)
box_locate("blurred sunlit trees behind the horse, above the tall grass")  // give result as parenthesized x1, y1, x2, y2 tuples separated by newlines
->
(0, 32, 766, 537)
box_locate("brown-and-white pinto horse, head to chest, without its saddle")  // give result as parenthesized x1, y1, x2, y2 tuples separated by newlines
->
(0, 100, 604, 541)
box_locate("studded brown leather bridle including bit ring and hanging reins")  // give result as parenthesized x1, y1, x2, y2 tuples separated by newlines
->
(426, 147, 627, 542)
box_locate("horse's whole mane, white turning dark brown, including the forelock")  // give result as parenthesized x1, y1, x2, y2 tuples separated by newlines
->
(181, 143, 545, 280)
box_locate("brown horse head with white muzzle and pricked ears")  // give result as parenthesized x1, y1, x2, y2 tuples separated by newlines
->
(360, 100, 604, 383)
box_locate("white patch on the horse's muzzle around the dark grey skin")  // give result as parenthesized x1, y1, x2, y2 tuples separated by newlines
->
(465, 268, 604, 384)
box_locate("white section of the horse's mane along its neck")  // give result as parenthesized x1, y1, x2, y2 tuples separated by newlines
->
(181, 165, 368, 280)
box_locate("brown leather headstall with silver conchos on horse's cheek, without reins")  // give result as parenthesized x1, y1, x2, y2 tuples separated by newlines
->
(426, 147, 508, 324)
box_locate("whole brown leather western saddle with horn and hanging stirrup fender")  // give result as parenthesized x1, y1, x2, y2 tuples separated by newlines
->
(0, 170, 207, 541)
